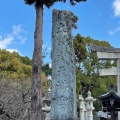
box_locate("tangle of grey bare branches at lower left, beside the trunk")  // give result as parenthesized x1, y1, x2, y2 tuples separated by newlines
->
(0, 80, 30, 120)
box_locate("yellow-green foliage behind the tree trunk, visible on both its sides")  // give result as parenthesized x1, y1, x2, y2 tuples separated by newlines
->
(0, 50, 48, 92)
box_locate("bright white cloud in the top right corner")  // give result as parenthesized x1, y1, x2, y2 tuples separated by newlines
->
(113, 0, 120, 17)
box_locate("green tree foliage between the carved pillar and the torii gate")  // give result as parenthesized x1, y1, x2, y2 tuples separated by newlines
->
(74, 35, 117, 110)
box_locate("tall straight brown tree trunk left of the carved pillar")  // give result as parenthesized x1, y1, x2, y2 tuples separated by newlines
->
(30, 4, 43, 120)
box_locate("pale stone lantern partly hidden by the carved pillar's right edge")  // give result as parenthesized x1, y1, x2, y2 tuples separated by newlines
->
(79, 95, 87, 120)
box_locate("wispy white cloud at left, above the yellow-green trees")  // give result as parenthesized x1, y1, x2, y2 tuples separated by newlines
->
(0, 25, 27, 49)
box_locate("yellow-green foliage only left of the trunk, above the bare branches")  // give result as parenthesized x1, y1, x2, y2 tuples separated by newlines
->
(0, 50, 32, 80)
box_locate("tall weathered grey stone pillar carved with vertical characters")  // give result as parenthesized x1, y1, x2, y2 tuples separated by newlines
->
(51, 10, 76, 120)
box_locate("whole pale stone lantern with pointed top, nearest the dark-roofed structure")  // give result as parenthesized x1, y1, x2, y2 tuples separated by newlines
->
(85, 91, 96, 120)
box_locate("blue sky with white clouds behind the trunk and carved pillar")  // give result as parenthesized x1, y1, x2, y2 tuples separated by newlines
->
(0, 0, 120, 62)
